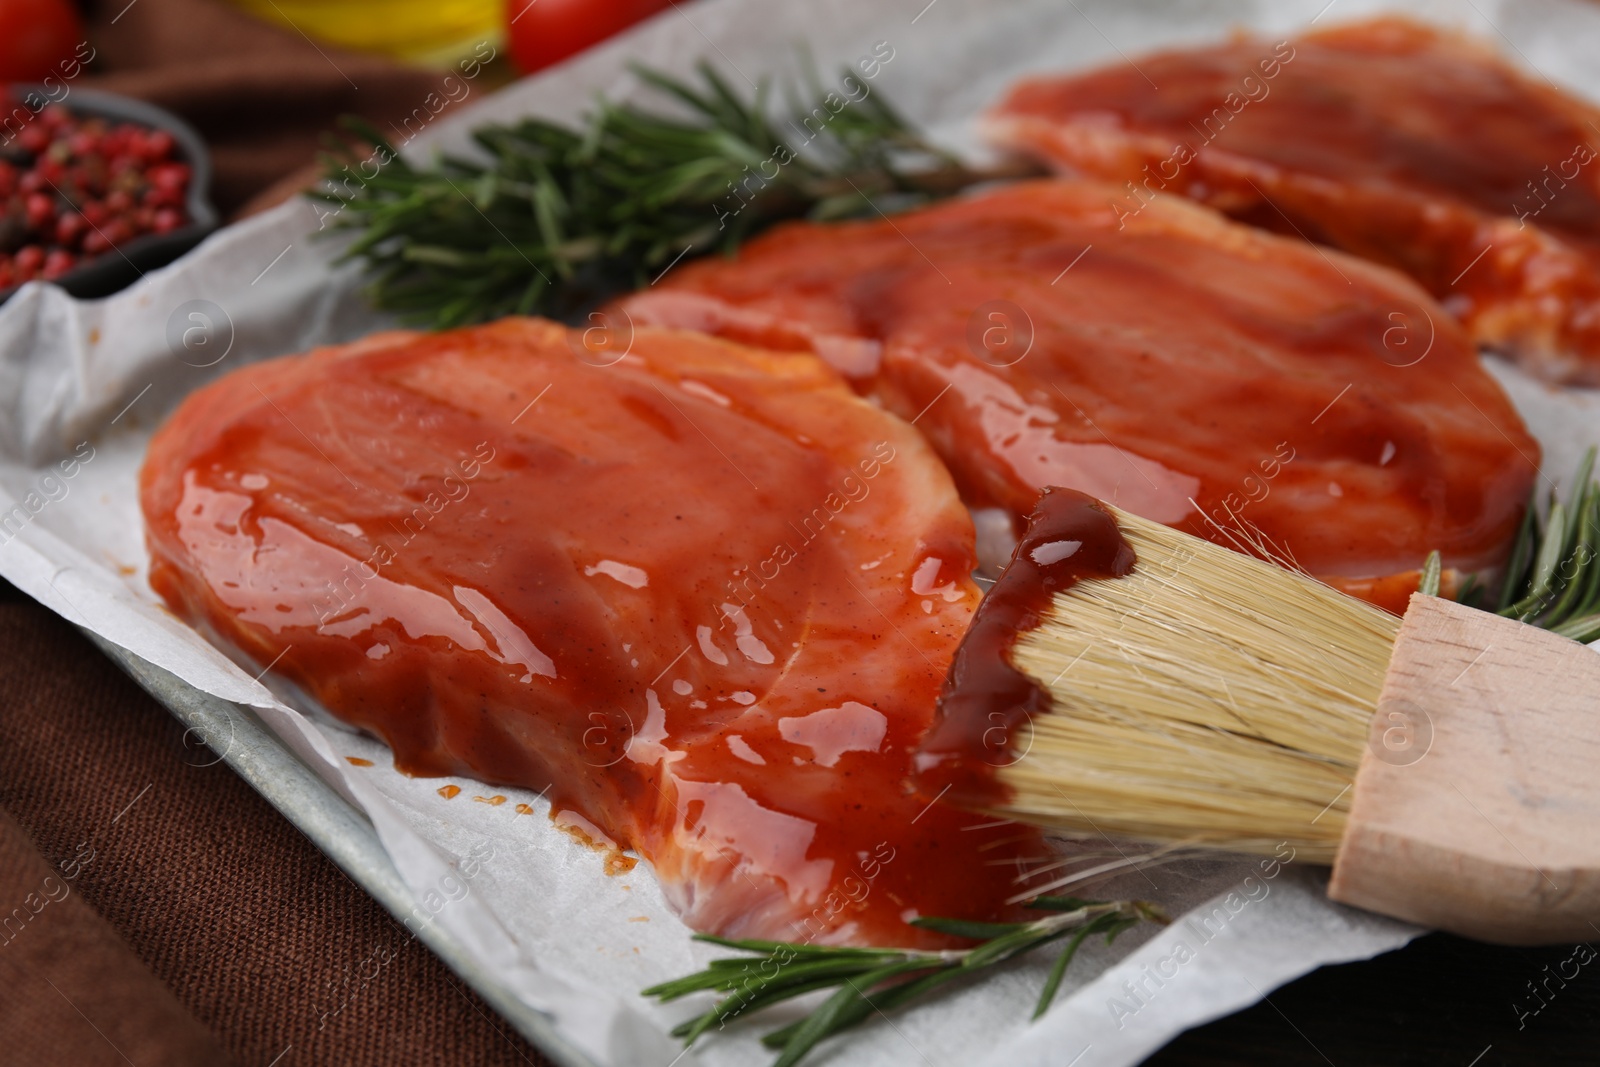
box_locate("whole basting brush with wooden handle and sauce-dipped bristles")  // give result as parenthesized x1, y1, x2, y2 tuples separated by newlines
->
(917, 490, 1600, 944)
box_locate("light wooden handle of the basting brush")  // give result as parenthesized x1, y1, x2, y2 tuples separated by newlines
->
(1328, 593, 1600, 944)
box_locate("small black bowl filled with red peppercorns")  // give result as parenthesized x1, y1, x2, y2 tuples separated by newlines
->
(0, 86, 218, 301)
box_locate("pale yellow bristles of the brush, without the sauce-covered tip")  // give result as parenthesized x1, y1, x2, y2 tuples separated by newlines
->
(1000, 509, 1400, 862)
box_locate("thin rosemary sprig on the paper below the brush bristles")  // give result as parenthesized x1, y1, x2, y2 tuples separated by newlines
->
(643, 896, 1170, 1067)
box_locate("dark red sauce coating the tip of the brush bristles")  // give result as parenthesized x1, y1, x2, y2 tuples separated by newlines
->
(915, 488, 1138, 808)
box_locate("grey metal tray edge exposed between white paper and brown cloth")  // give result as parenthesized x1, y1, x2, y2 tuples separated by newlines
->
(82, 630, 598, 1067)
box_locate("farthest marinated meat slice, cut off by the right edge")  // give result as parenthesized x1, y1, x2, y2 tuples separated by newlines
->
(992, 18, 1600, 386)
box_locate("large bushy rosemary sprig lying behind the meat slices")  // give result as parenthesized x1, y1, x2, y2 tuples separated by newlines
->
(310, 62, 1002, 328)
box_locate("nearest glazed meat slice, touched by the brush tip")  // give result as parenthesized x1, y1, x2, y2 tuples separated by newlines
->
(142, 320, 1042, 944)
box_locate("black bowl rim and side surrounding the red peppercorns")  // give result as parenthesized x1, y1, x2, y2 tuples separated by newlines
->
(0, 85, 218, 302)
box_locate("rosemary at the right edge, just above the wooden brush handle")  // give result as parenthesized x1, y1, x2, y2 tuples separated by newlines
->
(1496, 448, 1600, 641)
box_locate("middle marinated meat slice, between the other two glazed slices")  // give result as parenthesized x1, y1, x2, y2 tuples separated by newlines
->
(621, 181, 1539, 608)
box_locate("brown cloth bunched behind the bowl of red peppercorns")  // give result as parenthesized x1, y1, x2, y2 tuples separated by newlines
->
(77, 0, 464, 216)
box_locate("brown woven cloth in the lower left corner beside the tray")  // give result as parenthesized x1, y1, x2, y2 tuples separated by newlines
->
(0, 581, 549, 1067)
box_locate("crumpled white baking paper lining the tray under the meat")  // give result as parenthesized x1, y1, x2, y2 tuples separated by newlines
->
(0, 0, 1600, 1067)
